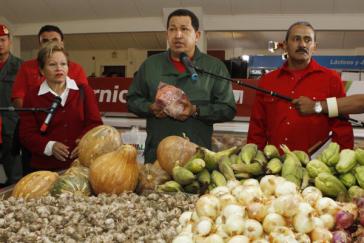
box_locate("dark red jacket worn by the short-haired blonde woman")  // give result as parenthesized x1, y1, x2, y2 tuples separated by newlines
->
(19, 85, 102, 170)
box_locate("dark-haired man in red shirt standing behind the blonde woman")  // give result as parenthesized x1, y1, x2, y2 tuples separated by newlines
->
(12, 25, 88, 107)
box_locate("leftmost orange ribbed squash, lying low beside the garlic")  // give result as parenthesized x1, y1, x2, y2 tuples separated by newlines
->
(11, 171, 59, 199)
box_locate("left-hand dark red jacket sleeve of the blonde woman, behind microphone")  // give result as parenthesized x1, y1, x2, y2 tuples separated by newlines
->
(19, 92, 50, 155)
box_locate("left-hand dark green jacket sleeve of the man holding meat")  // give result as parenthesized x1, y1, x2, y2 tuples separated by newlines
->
(127, 63, 154, 117)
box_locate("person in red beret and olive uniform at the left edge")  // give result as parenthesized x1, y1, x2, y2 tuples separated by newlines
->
(0, 24, 22, 186)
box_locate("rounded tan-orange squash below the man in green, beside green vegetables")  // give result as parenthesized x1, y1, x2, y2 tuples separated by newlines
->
(157, 136, 198, 175)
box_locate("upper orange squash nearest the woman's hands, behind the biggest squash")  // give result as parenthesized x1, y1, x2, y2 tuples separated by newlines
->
(78, 125, 122, 167)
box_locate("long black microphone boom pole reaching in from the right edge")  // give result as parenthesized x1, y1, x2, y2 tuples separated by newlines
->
(192, 64, 364, 127)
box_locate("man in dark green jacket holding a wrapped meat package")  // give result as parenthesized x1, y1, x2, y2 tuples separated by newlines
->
(127, 9, 236, 163)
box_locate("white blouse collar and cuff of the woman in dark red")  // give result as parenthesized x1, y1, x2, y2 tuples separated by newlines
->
(38, 77, 78, 156)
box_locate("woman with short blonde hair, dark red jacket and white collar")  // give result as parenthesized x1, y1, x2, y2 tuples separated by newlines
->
(19, 42, 102, 172)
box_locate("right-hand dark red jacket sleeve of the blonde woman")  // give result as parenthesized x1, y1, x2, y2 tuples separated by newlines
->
(80, 85, 103, 137)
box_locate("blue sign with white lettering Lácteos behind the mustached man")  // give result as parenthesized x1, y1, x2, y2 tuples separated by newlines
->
(249, 56, 364, 71)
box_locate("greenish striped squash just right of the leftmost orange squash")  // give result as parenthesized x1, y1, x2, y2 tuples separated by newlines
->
(51, 174, 91, 196)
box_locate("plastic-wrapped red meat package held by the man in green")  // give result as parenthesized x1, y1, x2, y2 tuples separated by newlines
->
(155, 82, 189, 118)
